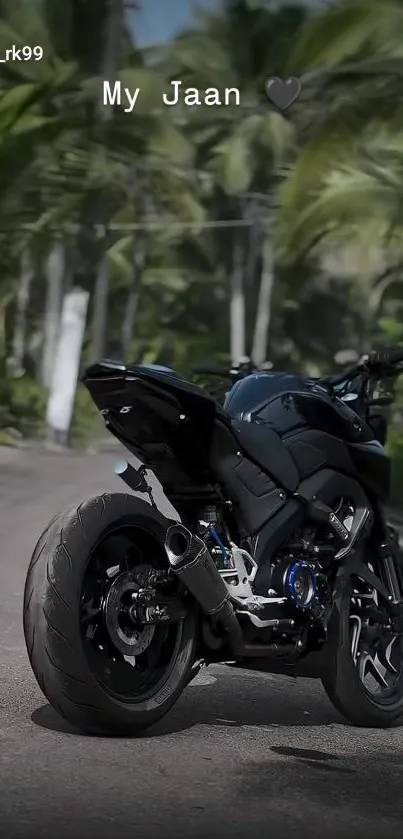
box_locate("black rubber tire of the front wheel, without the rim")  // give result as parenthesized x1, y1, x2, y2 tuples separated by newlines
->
(322, 578, 403, 728)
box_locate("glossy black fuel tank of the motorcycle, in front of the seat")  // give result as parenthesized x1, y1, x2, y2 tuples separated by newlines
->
(224, 372, 390, 500)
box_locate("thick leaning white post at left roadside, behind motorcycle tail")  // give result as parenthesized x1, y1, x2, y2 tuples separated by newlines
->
(46, 288, 89, 445)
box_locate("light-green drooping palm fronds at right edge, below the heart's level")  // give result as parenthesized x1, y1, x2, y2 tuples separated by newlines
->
(280, 129, 403, 333)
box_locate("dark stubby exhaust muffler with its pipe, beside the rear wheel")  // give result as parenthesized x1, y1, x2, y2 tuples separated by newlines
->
(165, 524, 294, 657)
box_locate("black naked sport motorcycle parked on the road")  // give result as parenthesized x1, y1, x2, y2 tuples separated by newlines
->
(24, 349, 403, 734)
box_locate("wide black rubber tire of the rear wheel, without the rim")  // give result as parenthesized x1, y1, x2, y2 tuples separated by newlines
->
(24, 493, 197, 735)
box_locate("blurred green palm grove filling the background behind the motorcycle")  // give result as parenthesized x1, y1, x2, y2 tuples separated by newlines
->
(0, 0, 403, 498)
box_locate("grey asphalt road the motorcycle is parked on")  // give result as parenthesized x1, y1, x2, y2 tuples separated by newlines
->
(0, 450, 403, 839)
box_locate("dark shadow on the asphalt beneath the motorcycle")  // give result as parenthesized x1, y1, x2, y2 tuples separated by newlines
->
(31, 673, 345, 739)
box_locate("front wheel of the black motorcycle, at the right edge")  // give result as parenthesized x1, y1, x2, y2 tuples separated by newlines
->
(322, 577, 403, 728)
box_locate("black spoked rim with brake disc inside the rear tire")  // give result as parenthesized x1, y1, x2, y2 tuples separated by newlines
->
(80, 533, 182, 701)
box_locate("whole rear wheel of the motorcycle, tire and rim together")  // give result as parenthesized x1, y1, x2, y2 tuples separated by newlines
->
(24, 493, 197, 735)
